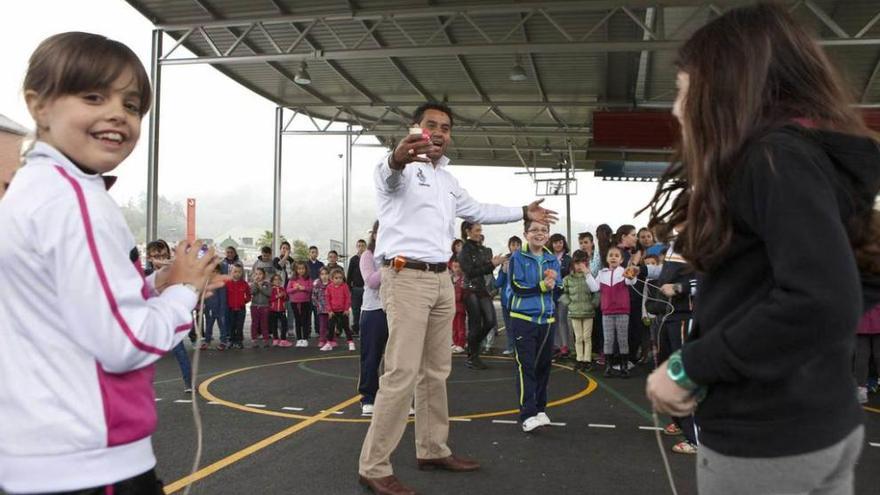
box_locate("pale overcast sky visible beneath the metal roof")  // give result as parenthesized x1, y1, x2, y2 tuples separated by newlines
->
(0, 0, 654, 254)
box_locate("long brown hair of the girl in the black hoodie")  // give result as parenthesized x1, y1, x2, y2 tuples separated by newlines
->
(639, 4, 880, 271)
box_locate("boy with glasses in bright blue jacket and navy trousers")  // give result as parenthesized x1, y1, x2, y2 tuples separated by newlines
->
(508, 220, 559, 432)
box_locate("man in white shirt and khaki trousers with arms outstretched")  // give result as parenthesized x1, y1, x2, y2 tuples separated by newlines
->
(358, 103, 556, 495)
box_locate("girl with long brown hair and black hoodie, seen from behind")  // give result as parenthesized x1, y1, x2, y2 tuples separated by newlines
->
(647, 5, 880, 495)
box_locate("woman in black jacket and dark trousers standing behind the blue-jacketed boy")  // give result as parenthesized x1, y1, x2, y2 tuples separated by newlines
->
(458, 222, 504, 370)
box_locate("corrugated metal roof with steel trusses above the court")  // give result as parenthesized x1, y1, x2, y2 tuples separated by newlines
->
(126, 0, 880, 166)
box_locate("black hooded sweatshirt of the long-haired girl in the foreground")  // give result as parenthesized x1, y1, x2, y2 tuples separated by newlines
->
(682, 125, 880, 457)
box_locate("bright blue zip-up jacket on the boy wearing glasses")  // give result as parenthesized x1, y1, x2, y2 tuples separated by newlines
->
(508, 245, 562, 324)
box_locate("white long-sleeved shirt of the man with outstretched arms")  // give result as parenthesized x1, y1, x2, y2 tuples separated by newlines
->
(374, 154, 523, 263)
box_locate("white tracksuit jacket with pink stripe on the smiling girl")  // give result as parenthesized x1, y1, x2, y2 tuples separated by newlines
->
(0, 143, 197, 493)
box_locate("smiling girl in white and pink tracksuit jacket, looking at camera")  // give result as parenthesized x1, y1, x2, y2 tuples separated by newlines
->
(0, 33, 222, 495)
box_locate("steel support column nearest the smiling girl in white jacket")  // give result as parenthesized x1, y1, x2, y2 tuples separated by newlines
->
(146, 29, 162, 242)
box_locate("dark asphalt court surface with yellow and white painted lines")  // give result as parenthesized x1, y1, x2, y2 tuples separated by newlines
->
(148, 337, 880, 495)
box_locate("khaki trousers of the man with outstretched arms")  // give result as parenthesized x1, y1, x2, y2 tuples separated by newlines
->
(358, 267, 455, 478)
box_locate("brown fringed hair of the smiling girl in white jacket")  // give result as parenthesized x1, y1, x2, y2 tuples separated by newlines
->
(24, 32, 152, 117)
